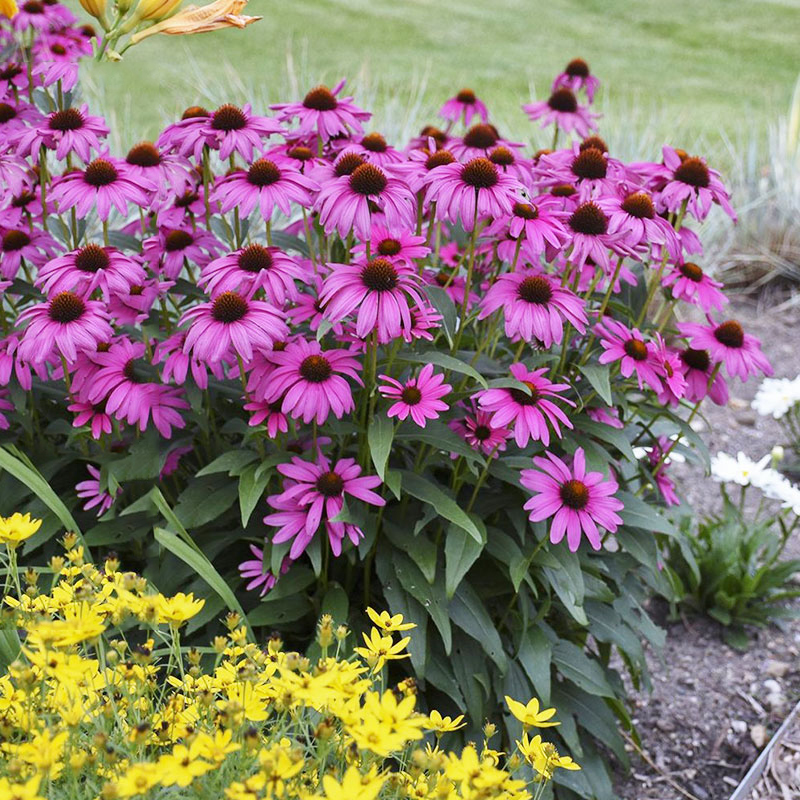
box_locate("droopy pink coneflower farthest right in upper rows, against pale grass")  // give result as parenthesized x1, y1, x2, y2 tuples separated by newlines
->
(655, 145, 736, 222)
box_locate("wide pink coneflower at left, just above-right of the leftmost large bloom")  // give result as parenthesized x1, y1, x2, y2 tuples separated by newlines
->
(35, 243, 147, 300)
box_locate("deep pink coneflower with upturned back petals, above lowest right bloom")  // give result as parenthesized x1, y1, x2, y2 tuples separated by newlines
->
(477, 364, 575, 447)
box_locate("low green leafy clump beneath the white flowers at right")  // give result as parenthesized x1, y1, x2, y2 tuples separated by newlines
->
(664, 493, 800, 648)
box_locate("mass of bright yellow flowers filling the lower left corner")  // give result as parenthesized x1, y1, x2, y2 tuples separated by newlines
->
(0, 515, 580, 800)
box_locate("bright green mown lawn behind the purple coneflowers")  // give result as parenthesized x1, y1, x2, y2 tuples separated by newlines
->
(76, 0, 800, 155)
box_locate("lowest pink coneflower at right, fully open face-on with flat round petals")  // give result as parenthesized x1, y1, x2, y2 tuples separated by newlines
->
(520, 447, 624, 553)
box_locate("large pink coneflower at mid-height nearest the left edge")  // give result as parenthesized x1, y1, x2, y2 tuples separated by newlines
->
(17, 292, 113, 364)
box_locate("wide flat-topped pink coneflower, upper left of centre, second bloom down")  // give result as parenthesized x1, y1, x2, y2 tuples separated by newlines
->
(211, 158, 319, 220)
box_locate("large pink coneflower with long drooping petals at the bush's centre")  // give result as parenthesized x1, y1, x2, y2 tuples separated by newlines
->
(319, 257, 425, 344)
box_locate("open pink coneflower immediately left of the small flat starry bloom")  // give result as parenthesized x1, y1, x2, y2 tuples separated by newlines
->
(255, 339, 361, 425)
